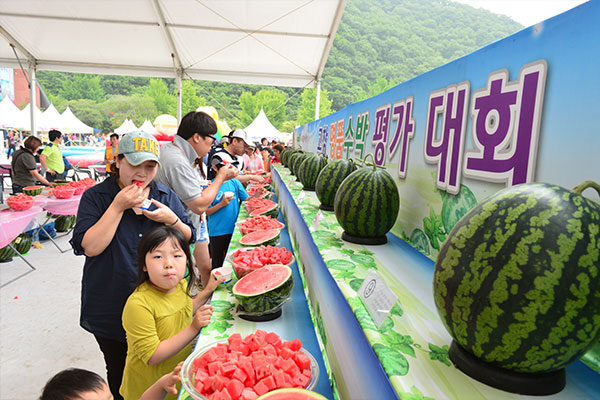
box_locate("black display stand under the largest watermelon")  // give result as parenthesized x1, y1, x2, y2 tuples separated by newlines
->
(449, 341, 566, 396)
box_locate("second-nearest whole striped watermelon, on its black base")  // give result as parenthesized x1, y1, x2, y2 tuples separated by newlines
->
(333, 158, 400, 245)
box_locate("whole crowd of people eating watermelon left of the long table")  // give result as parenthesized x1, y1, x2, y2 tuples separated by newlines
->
(6, 112, 283, 400)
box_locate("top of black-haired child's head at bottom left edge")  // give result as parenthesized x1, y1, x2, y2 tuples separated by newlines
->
(39, 368, 113, 400)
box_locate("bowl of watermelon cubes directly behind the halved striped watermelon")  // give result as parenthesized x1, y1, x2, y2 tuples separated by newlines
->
(227, 246, 296, 279)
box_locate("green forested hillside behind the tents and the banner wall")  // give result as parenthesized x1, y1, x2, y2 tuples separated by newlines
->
(34, 0, 522, 132)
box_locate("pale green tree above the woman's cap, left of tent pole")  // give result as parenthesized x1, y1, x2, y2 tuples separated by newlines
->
(102, 94, 160, 132)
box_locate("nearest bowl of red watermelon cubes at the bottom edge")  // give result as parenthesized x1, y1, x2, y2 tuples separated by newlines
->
(181, 329, 319, 400)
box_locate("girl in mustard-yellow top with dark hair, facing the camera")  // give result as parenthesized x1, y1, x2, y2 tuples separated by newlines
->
(120, 226, 223, 400)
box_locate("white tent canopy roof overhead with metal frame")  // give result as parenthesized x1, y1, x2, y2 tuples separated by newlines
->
(0, 0, 346, 87)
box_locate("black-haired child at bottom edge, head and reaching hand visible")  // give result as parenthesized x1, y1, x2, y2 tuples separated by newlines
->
(39, 363, 183, 400)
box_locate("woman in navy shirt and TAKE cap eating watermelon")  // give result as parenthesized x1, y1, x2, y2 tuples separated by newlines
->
(70, 132, 195, 399)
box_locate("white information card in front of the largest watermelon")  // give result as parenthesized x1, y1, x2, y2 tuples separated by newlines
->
(358, 272, 398, 328)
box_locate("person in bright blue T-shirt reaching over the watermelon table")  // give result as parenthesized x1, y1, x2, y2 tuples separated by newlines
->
(206, 173, 265, 269)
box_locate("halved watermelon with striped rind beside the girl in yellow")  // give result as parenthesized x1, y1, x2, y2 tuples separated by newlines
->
(232, 264, 294, 314)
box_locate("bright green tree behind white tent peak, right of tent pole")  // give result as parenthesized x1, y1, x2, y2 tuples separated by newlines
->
(238, 89, 286, 129)
